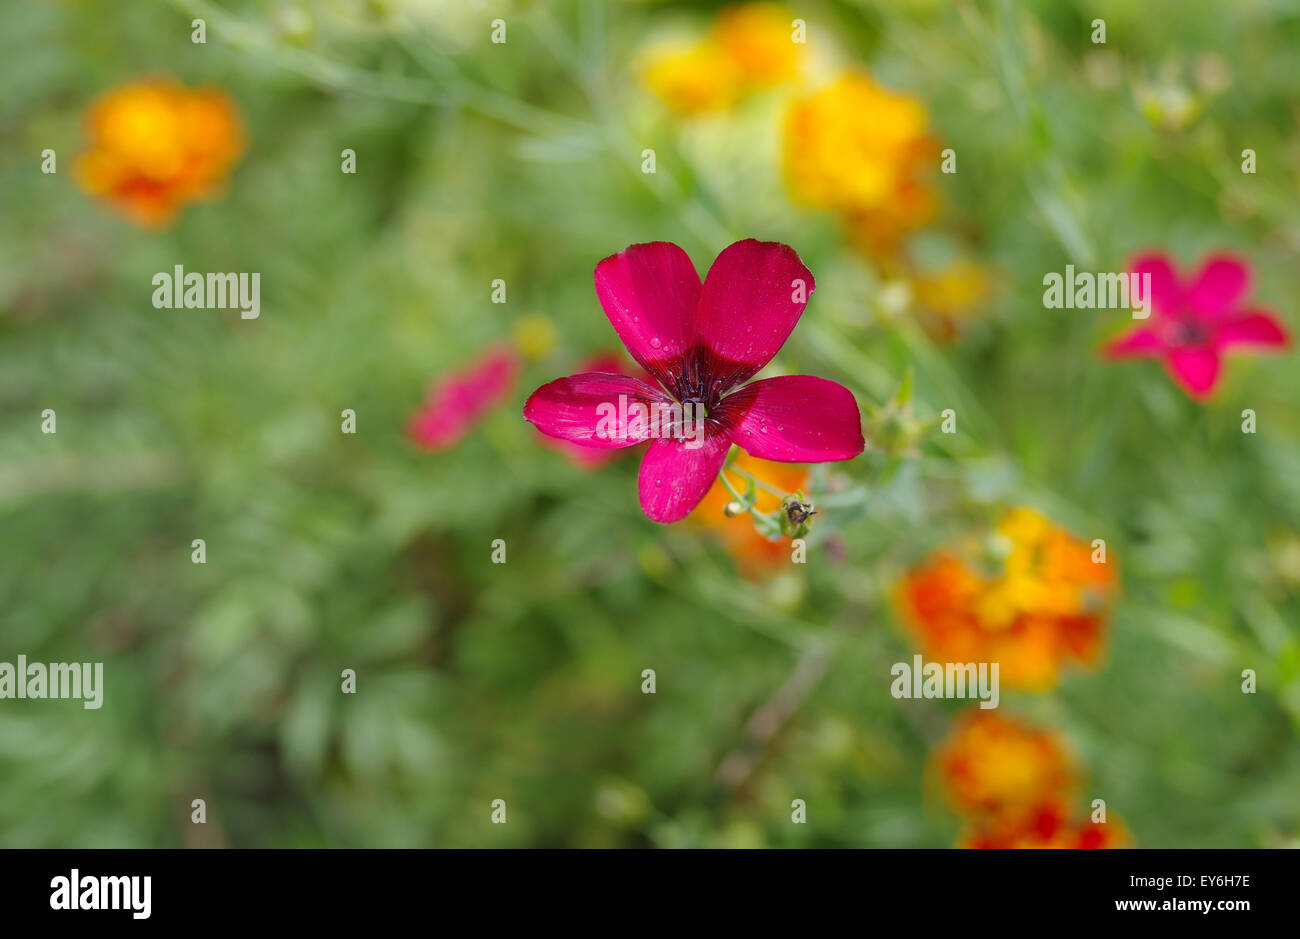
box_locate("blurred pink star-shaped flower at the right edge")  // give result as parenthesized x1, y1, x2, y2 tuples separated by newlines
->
(1105, 254, 1288, 401)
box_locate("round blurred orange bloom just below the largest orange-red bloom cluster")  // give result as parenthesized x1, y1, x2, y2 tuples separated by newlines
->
(933, 709, 1075, 825)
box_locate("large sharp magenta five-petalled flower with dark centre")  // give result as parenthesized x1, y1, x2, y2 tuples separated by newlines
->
(524, 239, 863, 523)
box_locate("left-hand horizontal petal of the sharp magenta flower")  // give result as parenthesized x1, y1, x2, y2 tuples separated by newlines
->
(524, 372, 668, 450)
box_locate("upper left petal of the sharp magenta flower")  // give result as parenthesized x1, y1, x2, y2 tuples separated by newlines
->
(595, 242, 699, 386)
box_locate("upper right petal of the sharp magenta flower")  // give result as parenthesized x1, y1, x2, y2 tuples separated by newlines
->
(696, 238, 816, 391)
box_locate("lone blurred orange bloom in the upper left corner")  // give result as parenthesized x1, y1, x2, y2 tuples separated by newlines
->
(77, 79, 244, 228)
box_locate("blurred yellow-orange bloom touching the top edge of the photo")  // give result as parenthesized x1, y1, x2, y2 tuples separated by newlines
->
(642, 3, 803, 113)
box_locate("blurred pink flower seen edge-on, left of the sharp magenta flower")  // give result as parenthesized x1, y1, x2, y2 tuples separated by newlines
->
(407, 347, 519, 450)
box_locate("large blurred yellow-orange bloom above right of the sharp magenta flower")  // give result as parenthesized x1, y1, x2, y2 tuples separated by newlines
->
(785, 72, 939, 254)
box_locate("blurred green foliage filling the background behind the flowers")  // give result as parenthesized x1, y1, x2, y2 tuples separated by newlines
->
(0, 0, 1300, 847)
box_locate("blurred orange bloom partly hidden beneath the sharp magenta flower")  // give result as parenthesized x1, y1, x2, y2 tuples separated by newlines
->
(688, 451, 809, 577)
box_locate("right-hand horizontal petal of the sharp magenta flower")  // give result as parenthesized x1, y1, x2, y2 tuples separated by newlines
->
(719, 375, 866, 463)
